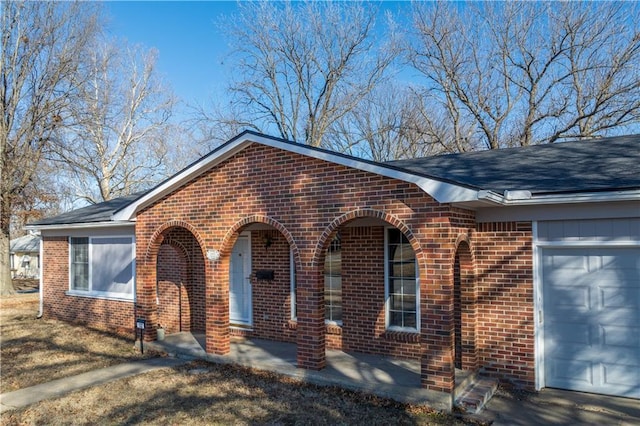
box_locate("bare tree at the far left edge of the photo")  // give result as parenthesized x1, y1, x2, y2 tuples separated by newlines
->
(0, 1, 97, 294)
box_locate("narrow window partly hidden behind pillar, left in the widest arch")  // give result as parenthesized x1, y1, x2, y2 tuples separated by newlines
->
(324, 233, 342, 324)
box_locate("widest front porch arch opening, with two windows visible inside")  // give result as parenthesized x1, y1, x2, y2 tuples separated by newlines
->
(314, 209, 423, 360)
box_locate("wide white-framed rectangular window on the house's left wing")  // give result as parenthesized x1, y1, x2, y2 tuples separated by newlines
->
(69, 236, 135, 299)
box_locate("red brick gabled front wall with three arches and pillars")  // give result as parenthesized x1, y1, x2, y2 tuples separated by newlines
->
(136, 144, 464, 391)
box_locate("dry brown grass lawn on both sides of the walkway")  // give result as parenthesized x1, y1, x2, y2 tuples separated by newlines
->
(0, 295, 480, 425)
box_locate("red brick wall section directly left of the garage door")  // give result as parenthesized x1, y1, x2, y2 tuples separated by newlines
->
(474, 222, 535, 389)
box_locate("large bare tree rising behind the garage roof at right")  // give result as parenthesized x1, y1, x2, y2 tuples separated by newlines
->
(409, 2, 640, 151)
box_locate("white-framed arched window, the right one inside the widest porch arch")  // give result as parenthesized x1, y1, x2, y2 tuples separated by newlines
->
(385, 228, 420, 331)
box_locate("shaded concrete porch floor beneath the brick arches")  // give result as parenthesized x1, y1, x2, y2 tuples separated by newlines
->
(144, 332, 460, 411)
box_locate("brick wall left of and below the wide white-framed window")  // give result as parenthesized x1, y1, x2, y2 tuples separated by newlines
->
(42, 235, 135, 338)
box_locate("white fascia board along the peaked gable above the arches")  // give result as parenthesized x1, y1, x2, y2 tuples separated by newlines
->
(113, 135, 478, 221)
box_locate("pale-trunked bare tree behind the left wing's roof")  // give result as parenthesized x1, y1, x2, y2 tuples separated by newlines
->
(55, 41, 174, 203)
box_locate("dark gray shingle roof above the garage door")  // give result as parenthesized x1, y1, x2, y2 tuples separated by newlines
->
(385, 135, 640, 194)
